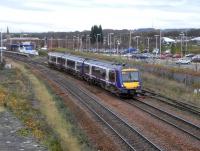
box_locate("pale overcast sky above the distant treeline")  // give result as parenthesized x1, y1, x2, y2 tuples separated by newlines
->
(0, 0, 200, 32)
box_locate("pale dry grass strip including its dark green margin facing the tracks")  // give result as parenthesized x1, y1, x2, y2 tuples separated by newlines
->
(13, 60, 92, 151)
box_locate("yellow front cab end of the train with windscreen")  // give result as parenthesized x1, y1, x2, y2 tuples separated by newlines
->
(120, 68, 141, 96)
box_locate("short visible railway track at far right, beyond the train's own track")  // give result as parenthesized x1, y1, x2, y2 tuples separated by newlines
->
(140, 90, 200, 116)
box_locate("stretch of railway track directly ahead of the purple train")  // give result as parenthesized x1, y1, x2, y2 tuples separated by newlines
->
(123, 98, 200, 141)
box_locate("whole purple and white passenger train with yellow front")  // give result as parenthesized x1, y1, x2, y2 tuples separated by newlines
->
(48, 52, 141, 96)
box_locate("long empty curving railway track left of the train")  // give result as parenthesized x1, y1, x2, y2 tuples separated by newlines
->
(7, 54, 161, 151)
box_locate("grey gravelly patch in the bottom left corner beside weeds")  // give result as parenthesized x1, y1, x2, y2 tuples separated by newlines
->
(0, 107, 47, 151)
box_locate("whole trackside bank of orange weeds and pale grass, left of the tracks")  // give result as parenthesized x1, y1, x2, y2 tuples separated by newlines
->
(0, 63, 93, 151)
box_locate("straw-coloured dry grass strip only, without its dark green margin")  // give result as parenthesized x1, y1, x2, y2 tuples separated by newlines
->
(12, 61, 86, 151)
